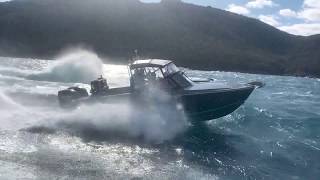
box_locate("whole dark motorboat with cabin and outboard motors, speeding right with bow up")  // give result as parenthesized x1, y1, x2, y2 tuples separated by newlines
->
(58, 59, 264, 121)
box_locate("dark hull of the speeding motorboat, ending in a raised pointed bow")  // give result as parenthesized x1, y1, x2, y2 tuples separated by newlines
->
(61, 84, 255, 122)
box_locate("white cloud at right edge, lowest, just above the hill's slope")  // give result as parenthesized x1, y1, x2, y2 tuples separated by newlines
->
(278, 23, 320, 36)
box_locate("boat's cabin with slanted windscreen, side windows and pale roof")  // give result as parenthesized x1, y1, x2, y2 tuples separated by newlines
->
(129, 59, 192, 90)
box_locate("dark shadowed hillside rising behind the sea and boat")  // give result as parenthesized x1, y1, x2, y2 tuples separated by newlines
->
(0, 0, 320, 77)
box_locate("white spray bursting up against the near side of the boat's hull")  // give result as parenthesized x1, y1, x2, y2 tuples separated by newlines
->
(44, 89, 187, 143)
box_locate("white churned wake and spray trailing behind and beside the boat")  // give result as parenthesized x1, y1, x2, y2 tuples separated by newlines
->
(0, 50, 186, 143)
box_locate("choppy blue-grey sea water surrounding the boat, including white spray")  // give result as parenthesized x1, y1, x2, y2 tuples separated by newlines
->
(0, 52, 320, 180)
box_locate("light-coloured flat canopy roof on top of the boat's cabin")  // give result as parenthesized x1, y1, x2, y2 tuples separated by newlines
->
(130, 59, 172, 69)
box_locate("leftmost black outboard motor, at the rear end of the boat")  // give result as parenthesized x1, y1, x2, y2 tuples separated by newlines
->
(58, 87, 89, 106)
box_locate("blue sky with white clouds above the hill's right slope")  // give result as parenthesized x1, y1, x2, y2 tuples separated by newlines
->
(141, 0, 320, 36)
